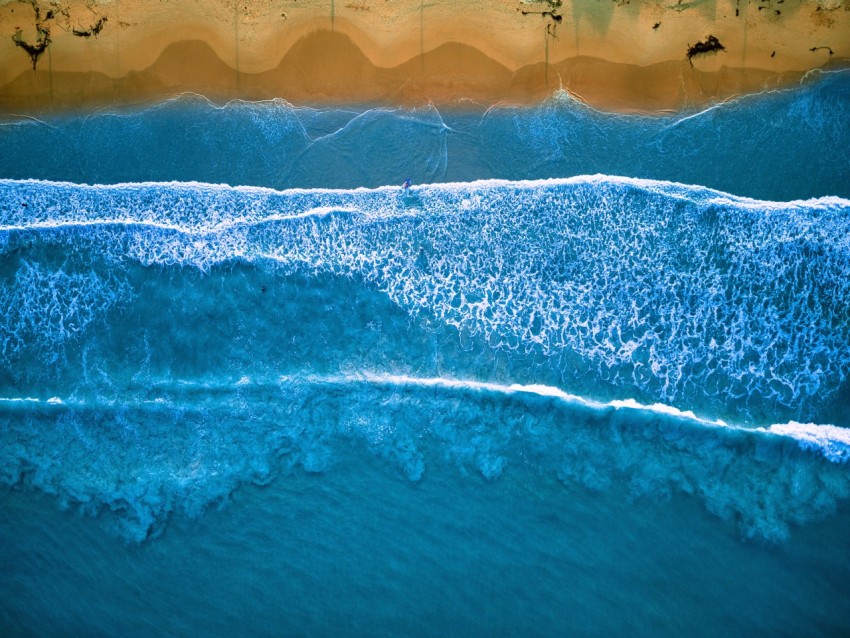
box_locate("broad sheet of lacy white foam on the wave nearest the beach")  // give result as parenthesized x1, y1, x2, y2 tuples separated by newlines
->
(0, 175, 850, 424)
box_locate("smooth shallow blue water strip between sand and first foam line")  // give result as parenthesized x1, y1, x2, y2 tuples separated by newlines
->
(0, 71, 850, 201)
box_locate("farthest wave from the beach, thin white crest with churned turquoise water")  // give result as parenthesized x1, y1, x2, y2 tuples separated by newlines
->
(0, 374, 850, 541)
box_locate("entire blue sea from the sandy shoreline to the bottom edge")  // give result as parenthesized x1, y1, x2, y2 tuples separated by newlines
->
(0, 72, 850, 636)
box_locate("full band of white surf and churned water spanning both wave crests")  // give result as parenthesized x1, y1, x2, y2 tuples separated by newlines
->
(0, 176, 850, 540)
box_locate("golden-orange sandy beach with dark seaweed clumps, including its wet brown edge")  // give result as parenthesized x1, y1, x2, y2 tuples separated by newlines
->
(0, 0, 850, 113)
